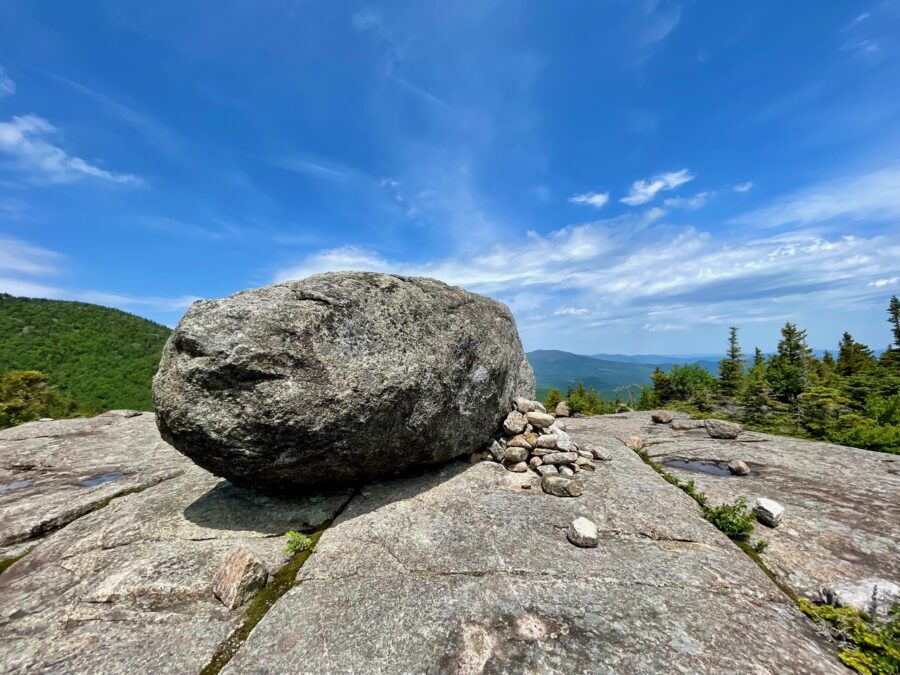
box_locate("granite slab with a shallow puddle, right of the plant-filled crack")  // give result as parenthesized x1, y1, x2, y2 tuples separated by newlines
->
(566, 412, 900, 599)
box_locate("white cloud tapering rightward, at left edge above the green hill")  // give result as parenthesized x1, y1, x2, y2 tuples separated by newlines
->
(0, 115, 140, 183)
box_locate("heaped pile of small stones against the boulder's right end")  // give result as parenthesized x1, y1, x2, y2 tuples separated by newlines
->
(472, 397, 609, 497)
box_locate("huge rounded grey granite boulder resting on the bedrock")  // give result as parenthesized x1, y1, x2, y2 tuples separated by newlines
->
(153, 272, 534, 490)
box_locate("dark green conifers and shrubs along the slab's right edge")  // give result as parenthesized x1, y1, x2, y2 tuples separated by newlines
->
(545, 296, 900, 453)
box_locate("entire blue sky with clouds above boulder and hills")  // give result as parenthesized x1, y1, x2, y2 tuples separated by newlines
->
(0, 0, 900, 353)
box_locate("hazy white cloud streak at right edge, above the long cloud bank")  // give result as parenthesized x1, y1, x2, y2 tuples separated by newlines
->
(732, 167, 900, 227)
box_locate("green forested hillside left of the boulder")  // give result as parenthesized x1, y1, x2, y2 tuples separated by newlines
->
(0, 294, 171, 410)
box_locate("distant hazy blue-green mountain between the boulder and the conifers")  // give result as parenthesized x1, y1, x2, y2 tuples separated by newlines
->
(527, 349, 656, 398)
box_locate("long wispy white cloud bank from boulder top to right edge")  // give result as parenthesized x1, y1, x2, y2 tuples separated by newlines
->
(276, 209, 900, 327)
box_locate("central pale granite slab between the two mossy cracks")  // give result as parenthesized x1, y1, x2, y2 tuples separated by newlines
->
(223, 425, 846, 675)
